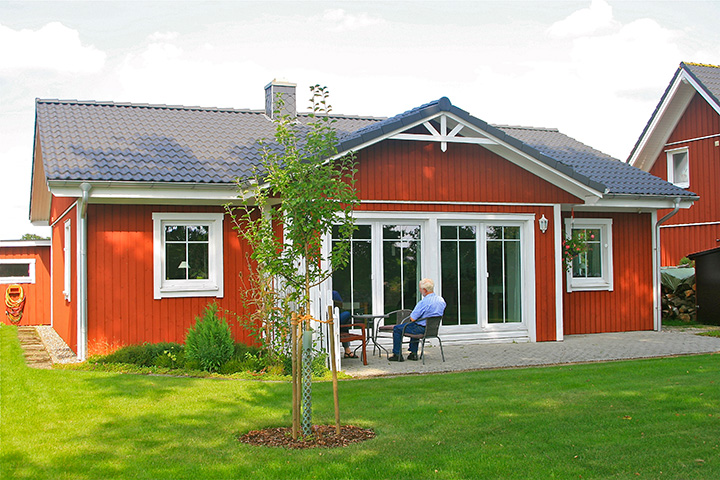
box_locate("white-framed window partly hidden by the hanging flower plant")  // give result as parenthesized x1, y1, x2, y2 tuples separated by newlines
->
(565, 218, 613, 292)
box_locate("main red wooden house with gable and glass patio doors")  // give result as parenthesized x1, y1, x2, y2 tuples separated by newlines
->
(31, 82, 696, 357)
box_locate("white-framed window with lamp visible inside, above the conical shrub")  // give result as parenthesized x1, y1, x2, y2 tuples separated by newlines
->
(153, 213, 223, 299)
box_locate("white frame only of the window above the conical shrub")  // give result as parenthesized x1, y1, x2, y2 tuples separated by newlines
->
(152, 212, 224, 300)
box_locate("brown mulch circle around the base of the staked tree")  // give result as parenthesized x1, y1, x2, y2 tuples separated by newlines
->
(238, 425, 375, 448)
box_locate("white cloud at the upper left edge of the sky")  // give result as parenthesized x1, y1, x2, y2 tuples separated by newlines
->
(0, 22, 106, 73)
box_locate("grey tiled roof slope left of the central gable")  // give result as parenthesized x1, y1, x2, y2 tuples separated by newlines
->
(36, 100, 377, 183)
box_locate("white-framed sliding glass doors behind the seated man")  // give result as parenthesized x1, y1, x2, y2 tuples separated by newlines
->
(332, 217, 534, 334)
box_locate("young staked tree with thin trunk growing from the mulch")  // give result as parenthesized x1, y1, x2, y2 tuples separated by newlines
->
(231, 85, 359, 436)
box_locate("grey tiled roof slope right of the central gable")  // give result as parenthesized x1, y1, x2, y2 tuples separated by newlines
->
(497, 126, 695, 197)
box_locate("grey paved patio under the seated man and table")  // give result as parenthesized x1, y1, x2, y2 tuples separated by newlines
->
(342, 329, 720, 377)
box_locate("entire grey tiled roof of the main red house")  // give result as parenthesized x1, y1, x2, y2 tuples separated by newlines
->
(36, 97, 694, 200)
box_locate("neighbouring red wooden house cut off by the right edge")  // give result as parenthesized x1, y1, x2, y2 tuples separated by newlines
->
(628, 63, 720, 266)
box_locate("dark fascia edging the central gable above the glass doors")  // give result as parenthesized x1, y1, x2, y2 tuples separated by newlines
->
(338, 97, 607, 194)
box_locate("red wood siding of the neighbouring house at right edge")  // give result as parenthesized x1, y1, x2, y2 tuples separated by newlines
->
(650, 94, 720, 266)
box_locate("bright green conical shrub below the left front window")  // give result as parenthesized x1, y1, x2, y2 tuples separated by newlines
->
(185, 303, 235, 372)
